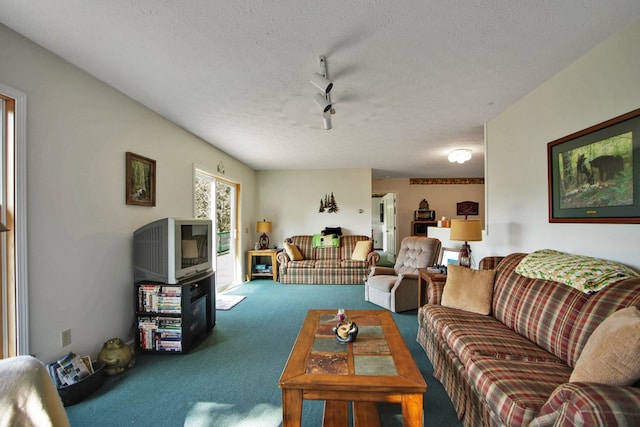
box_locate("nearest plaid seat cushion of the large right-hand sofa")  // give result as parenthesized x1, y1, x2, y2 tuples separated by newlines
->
(467, 356, 571, 426)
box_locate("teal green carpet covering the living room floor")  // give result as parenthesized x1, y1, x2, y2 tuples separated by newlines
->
(67, 280, 460, 427)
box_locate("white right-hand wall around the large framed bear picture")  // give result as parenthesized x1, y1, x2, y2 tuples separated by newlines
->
(482, 19, 640, 270)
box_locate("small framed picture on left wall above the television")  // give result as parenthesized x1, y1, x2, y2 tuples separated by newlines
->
(125, 152, 156, 206)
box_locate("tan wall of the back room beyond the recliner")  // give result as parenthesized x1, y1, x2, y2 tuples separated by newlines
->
(371, 177, 485, 251)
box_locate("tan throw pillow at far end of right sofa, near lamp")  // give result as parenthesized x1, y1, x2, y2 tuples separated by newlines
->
(441, 264, 496, 315)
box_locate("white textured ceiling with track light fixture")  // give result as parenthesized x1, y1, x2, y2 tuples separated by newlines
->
(0, 0, 640, 178)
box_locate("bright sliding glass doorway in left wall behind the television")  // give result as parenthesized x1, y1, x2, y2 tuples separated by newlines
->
(195, 168, 240, 293)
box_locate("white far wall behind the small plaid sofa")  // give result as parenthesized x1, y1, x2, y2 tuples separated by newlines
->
(258, 169, 371, 247)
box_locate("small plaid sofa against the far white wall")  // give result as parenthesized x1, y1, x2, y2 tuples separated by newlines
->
(277, 235, 380, 285)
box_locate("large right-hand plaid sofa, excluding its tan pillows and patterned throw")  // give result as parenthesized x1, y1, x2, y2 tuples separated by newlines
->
(417, 253, 640, 426)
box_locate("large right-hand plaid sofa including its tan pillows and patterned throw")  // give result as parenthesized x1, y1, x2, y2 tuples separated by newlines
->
(418, 250, 640, 426)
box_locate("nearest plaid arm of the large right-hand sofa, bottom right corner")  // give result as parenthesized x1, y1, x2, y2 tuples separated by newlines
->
(529, 383, 640, 427)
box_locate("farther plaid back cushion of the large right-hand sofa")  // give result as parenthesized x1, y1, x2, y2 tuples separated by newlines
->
(493, 253, 589, 362)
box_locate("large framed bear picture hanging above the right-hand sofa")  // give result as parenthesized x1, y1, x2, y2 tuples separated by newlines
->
(547, 109, 640, 223)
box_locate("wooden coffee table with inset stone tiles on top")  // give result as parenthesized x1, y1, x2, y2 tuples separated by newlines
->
(279, 309, 427, 427)
